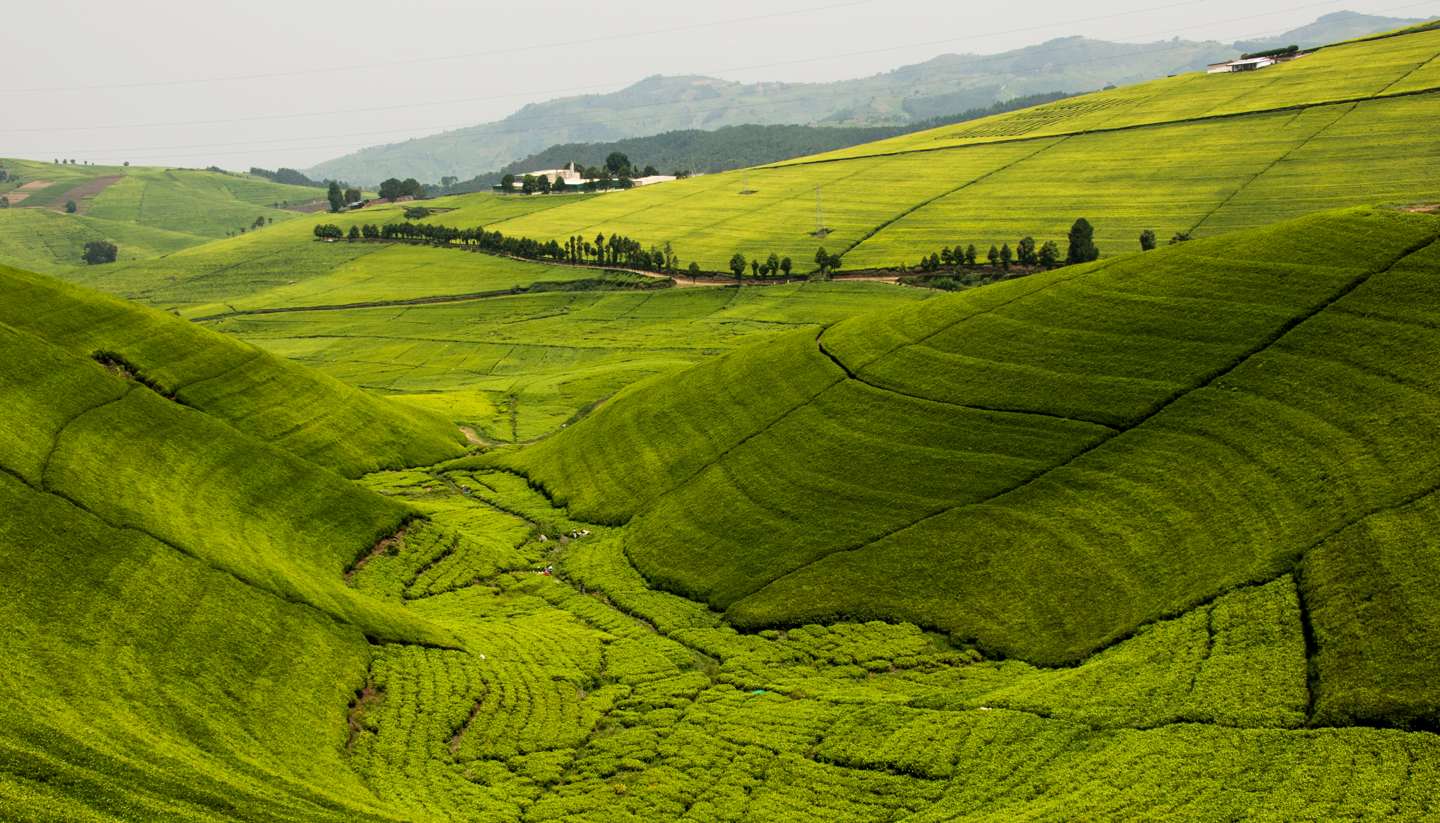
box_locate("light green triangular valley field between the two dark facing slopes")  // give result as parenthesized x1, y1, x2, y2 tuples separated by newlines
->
(217, 279, 930, 442)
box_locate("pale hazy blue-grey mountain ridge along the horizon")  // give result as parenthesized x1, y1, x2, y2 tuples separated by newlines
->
(305, 12, 1428, 184)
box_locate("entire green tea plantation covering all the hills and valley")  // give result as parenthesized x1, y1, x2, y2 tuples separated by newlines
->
(0, 16, 1440, 823)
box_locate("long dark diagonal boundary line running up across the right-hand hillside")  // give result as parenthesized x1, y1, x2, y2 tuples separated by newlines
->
(737, 232, 1440, 635)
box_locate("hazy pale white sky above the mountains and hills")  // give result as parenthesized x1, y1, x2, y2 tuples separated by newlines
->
(0, 0, 1440, 168)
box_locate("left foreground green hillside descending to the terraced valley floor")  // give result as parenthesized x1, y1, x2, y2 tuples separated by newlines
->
(0, 282, 483, 820)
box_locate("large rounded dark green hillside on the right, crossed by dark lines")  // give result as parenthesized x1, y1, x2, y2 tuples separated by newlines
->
(510, 210, 1440, 693)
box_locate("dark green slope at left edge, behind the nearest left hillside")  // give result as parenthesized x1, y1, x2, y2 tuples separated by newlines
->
(0, 269, 459, 476)
